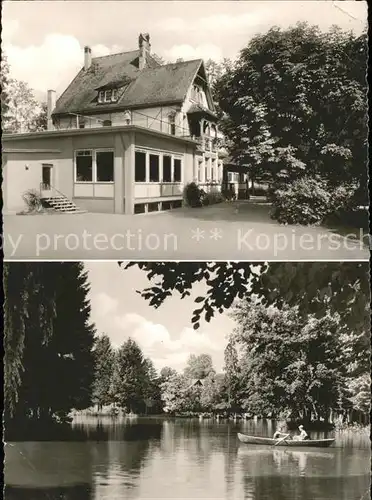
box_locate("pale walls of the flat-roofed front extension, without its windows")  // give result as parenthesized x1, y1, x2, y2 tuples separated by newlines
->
(3, 127, 195, 214)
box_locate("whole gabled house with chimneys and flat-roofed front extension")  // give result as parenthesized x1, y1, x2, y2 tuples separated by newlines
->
(2, 34, 223, 214)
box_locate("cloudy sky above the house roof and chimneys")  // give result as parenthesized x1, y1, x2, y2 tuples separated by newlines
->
(2, 0, 367, 100)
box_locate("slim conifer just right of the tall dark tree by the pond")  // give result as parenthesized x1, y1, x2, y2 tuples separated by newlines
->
(92, 335, 115, 408)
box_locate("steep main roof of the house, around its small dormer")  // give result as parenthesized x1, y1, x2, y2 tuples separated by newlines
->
(53, 50, 202, 115)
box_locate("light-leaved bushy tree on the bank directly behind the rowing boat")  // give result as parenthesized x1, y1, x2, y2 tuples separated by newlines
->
(234, 301, 346, 421)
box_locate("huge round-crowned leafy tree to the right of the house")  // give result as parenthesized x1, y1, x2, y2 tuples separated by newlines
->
(214, 23, 367, 210)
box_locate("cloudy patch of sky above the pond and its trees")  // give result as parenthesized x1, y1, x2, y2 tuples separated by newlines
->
(84, 261, 234, 372)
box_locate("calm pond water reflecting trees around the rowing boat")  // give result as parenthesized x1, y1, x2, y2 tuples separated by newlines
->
(5, 417, 370, 500)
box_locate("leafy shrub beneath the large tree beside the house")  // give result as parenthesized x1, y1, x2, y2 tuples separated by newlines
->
(271, 177, 355, 225)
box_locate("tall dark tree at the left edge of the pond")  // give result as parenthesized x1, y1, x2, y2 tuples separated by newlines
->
(4, 263, 94, 428)
